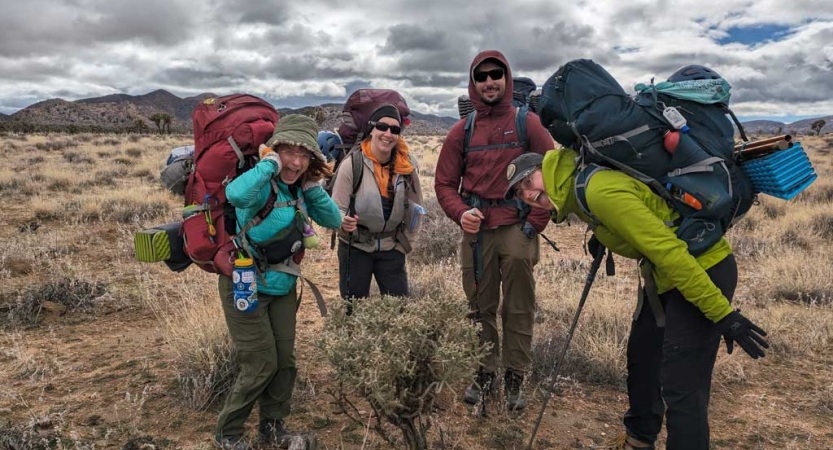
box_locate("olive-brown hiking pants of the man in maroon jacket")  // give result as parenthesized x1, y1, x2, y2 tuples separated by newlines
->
(460, 224, 540, 375)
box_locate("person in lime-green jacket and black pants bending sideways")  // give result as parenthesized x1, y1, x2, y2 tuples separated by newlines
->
(505, 149, 769, 450)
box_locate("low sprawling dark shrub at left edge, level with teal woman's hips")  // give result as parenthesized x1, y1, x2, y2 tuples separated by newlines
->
(6, 278, 107, 327)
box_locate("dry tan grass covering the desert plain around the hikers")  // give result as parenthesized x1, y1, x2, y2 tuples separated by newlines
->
(0, 134, 833, 449)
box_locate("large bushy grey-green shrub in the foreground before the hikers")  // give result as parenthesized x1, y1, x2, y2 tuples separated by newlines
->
(317, 296, 483, 449)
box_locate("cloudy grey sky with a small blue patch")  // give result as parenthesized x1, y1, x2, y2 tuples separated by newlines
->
(0, 0, 833, 122)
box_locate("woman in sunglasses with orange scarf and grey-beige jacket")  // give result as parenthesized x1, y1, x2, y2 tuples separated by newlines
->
(332, 105, 422, 312)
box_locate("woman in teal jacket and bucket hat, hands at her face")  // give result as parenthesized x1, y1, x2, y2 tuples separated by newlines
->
(215, 115, 341, 450)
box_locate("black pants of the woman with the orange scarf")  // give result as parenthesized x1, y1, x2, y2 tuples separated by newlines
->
(338, 242, 408, 299)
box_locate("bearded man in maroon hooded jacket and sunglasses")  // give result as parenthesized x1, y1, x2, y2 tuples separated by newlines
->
(434, 50, 555, 409)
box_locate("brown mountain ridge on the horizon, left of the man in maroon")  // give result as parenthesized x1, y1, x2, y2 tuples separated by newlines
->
(0, 89, 456, 134)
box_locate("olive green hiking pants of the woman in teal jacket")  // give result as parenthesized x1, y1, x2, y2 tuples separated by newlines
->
(216, 275, 298, 438)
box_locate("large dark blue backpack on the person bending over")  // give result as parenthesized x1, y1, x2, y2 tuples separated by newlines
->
(539, 59, 756, 256)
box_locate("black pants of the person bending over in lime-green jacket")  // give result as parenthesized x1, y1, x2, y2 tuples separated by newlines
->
(624, 255, 738, 450)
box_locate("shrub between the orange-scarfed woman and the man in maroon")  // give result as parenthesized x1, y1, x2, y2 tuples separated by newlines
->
(408, 197, 462, 264)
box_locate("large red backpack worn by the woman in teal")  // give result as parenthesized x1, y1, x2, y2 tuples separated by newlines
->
(182, 94, 280, 276)
